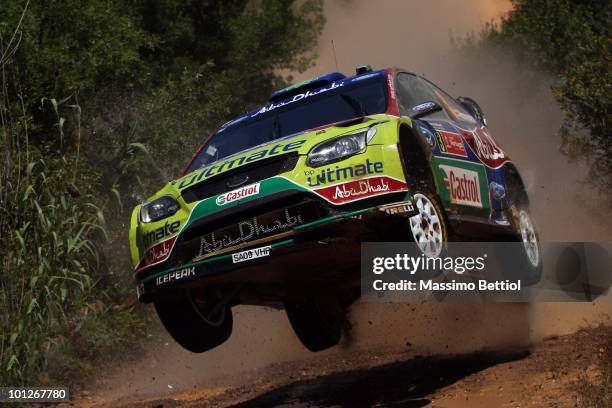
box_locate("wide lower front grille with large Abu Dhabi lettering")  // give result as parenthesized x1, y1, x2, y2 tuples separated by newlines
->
(181, 200, 324, 261)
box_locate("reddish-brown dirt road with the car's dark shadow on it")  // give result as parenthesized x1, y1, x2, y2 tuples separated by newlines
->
(76, 318, 612, 408)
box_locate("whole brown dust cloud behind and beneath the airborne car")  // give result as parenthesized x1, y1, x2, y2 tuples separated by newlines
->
(92, 0, 612, 398)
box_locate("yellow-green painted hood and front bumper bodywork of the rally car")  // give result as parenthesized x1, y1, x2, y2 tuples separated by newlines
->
(130, 115, 411, 300)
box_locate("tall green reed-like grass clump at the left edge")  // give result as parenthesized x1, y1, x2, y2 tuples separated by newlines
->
(0, 158, 101, 384)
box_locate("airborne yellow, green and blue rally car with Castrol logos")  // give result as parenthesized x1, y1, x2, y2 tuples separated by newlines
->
(130, 66, 541, 352)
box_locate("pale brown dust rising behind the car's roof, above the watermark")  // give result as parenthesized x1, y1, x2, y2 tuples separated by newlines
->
(296, 0, 612, 242)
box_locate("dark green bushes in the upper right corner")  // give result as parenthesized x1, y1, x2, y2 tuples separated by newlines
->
(471, 0, 612, 197)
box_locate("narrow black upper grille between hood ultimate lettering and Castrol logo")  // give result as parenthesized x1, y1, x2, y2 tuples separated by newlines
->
(182, 153, 299, 203)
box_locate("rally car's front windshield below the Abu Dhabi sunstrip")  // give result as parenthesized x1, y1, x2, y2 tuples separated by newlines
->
(187, 77, 387, 173)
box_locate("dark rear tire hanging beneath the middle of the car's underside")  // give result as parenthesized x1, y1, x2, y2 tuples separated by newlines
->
(285, 301, 342, 352)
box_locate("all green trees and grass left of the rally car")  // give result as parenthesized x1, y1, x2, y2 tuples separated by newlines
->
(0, 0, 324, 385)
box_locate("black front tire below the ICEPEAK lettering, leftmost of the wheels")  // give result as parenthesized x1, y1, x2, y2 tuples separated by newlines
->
(155, 292, 233, 353)
